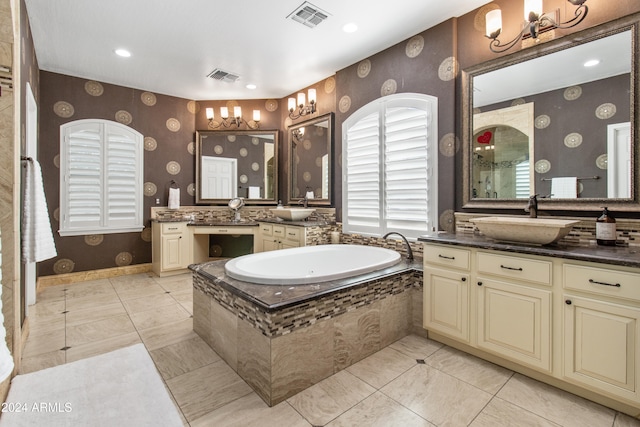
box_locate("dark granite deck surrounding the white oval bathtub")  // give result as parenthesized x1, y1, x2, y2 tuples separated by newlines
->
(189, 258, 423, 312)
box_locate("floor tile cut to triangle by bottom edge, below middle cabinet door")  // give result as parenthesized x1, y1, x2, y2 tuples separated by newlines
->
(470, 397, 559, 427)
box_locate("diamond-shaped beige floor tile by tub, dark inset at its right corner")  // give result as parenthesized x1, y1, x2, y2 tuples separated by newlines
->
(347, 347, 416, 389)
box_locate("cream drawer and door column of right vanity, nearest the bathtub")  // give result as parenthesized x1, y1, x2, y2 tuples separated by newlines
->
(423, 245, 471, 343)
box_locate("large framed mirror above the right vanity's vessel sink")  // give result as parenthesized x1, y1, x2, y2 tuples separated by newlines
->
(462, 15, 640, 211)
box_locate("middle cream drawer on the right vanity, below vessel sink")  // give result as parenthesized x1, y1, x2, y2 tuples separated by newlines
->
(478, 252, 552, 285)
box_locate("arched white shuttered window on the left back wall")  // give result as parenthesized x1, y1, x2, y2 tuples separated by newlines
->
(59, 120, 144, 236)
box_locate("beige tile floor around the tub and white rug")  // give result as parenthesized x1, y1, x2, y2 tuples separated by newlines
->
(22, 274, 640, 427)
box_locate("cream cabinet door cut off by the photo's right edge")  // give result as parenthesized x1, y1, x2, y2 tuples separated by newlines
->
(563, 295, 640, 403)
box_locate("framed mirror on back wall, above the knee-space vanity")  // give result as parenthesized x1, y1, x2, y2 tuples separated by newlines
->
(196, 130, 278, 205)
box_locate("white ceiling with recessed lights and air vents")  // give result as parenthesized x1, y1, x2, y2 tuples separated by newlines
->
(26, 0, 490, 100)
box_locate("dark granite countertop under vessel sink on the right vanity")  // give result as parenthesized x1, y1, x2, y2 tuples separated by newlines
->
(418, 233, 640, 268)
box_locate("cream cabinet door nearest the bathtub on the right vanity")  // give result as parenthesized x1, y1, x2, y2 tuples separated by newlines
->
(423, 267, 469, 342)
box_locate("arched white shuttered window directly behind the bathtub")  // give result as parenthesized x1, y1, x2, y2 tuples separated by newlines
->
(342, 94, 438, 238)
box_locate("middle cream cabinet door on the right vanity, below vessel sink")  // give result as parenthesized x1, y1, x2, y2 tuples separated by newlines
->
(477, 277, 551, 371)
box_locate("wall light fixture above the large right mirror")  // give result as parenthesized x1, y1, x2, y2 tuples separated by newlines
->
(485, 0, 589, 53)
